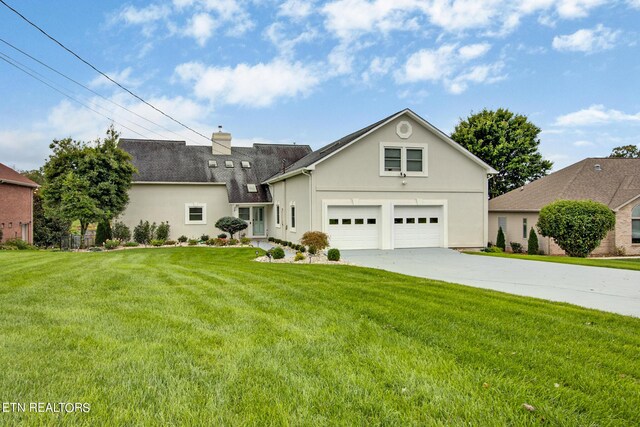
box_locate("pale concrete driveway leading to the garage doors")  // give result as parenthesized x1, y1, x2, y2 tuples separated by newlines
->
(342, 248, 640, 317)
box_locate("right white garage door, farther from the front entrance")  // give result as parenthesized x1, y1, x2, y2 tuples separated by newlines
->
(393, 206, 444, 248)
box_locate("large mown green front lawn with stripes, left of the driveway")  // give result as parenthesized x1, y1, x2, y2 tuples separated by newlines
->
(0, 247, 640, 426)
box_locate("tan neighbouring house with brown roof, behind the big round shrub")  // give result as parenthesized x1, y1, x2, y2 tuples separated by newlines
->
(489, 158, 640, 255)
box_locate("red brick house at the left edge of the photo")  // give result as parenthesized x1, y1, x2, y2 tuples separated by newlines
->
(0, 163, 38, 243)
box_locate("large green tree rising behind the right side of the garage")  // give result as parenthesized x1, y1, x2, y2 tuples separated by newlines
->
(451, 108, 553, 198)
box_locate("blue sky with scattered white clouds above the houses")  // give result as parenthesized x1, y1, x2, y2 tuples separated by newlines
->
(0, 0, 640, 169)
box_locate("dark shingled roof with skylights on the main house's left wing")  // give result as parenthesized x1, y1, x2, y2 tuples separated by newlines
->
(118, 138, 311, 203)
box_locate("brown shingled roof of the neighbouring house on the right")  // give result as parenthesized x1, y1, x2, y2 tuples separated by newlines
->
(489, 158, 640, 211)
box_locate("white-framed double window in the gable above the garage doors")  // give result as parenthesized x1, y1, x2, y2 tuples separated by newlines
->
(380, 142, 427, 176)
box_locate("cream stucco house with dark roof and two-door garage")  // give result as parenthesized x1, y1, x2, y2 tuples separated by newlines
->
(120, 109, 496, 249)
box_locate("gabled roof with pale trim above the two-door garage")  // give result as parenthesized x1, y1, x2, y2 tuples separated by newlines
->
(267, 108, 498, 182)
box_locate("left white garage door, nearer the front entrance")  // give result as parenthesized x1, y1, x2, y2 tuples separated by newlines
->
(327, 206, 380, 249)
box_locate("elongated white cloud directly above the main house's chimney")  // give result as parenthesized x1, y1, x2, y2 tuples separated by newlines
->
(175, 59, 320, 107)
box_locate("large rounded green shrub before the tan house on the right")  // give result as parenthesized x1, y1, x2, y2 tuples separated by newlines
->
(537, 200, 616, 257)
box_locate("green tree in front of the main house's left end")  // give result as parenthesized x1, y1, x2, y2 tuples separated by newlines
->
(42, 126, 135, 246)
